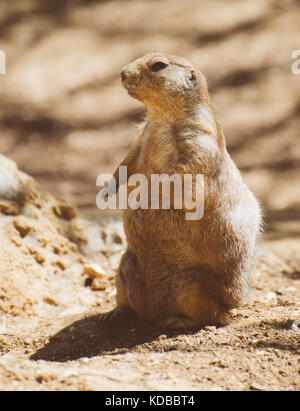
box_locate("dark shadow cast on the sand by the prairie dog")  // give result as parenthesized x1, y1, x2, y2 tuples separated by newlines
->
(31, 310, 168, 362)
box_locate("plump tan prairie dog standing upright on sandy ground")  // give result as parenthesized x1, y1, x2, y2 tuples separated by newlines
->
(109, 53, 261, 329)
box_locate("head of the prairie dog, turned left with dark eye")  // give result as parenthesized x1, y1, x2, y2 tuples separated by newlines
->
(120, 53, 208, 121)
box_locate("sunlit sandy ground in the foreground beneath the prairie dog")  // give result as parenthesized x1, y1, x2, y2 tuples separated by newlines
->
(0, 251, 300, 391)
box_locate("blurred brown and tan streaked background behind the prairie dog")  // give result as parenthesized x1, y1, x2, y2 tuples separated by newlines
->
(0, 0, 300, 239)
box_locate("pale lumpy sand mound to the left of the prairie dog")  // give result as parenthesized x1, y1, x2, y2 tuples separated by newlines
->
(0, 156, 113, 316)
